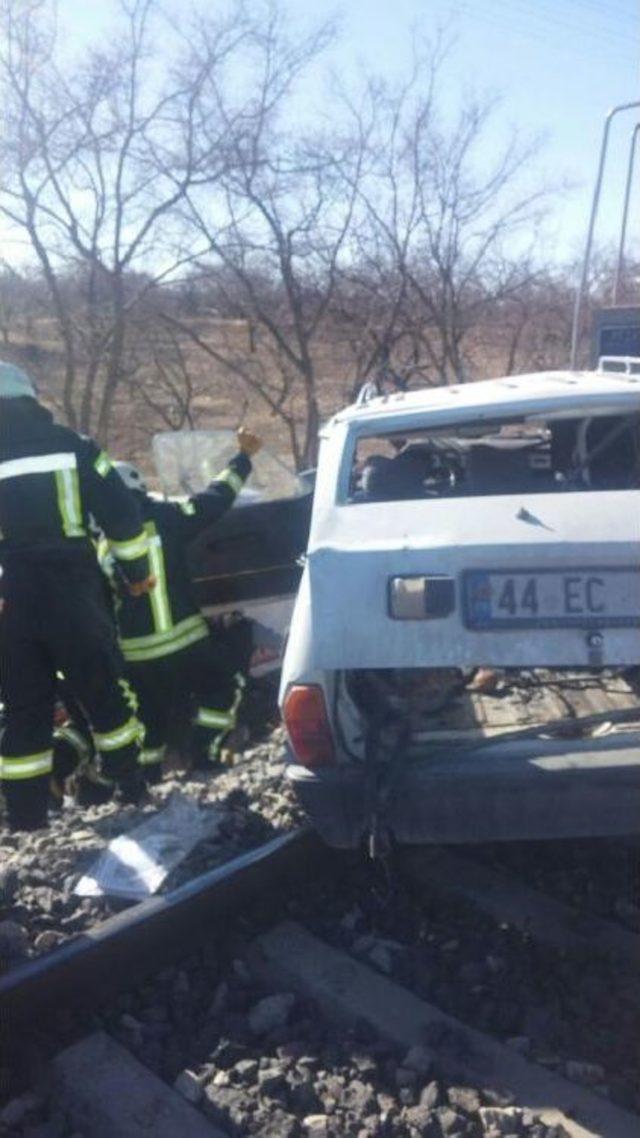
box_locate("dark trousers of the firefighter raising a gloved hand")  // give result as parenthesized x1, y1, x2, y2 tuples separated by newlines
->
(128, 637, 245, 782)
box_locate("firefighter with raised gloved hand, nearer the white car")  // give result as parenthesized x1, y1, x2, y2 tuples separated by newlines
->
(109, 428, 262, 783)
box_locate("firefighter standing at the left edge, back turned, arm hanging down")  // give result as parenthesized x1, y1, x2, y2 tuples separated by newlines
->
(0, 362, 154, 830)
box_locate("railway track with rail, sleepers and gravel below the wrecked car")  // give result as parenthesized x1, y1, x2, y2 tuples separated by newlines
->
(0, 828, 640, 1138)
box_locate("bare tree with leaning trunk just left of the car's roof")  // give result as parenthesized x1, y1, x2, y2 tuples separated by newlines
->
(163, 10, 364, 468)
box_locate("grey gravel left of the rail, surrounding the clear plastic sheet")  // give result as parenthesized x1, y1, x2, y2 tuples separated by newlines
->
(0, 727, 301, 973)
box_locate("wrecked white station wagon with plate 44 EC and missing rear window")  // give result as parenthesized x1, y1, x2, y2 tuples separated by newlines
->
(280, 361, 640, 847)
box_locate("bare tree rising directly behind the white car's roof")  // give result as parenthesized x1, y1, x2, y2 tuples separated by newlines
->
(346, 56, 547, 382)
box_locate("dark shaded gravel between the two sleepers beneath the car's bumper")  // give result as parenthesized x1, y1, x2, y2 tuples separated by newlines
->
(296, 855, 640, 1111)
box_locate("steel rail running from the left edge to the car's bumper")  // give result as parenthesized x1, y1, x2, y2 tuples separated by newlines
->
(0, 827, 318, 1034)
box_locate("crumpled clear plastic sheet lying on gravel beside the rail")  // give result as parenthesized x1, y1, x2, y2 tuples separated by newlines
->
(74, 794, 222, 901)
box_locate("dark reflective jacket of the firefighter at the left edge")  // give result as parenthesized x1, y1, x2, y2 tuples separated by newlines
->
(0, 399, 149, 582)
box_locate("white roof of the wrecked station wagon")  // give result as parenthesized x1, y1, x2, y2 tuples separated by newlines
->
(328, 371, 640, 427)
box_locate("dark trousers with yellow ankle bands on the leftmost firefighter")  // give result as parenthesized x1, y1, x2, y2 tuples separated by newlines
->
(0, 550, 143, 830)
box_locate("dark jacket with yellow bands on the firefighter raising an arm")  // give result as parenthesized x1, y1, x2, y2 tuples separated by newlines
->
(114, 453, 252, 663)
